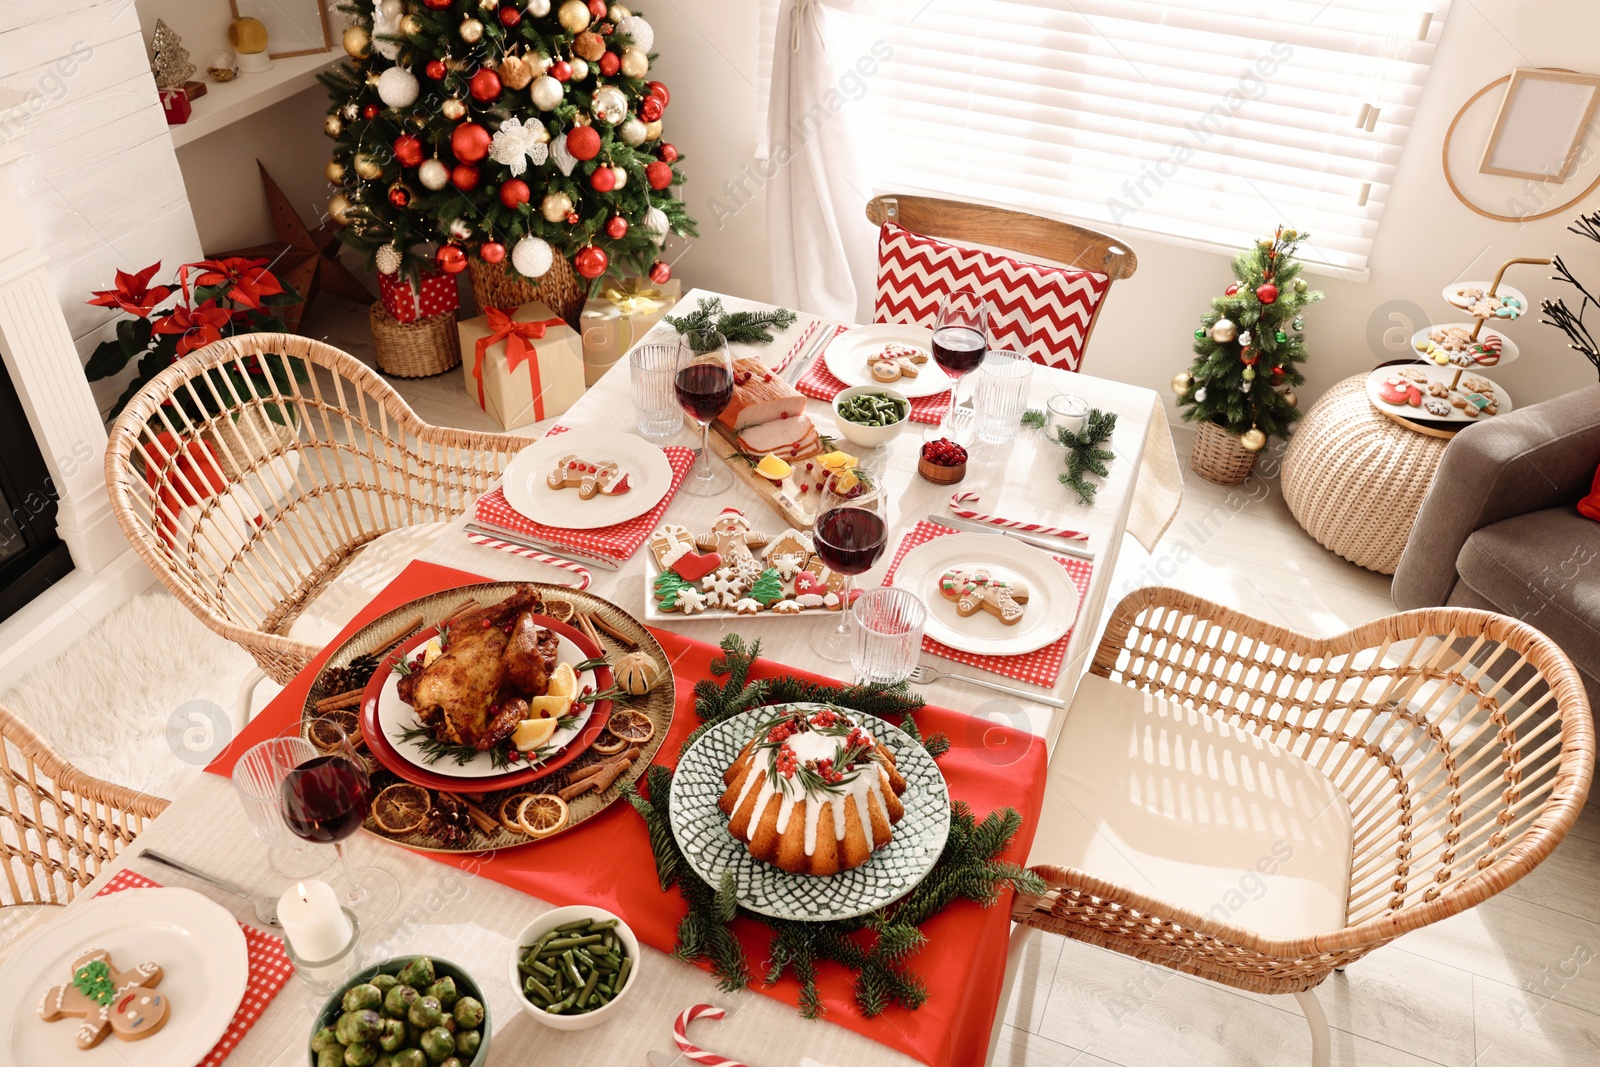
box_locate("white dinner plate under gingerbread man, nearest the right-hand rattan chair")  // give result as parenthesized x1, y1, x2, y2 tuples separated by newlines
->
(894, 533, 1078, 656)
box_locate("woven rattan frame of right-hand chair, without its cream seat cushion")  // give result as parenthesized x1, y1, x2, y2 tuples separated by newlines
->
(1002, 589, 1595, 1067)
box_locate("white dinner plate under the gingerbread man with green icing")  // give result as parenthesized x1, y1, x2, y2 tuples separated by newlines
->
(0, 889, 250, 1067)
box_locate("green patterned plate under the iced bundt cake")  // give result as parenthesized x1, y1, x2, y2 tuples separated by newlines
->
(672, 704, 950, 923)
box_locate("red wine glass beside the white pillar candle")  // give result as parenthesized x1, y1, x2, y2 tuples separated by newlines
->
(278, 721, 400, 915)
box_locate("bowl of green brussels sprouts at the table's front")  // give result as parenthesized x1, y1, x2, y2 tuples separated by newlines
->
(310, 957, 490, 1067)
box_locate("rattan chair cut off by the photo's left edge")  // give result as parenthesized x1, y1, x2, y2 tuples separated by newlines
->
(0, 707, 166, 910)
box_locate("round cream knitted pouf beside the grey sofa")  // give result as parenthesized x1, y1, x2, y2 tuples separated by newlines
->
(1282, 374, 1450, 574)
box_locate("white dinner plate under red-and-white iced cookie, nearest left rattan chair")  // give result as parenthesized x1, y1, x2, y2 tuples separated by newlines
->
(504, 430, 672, 530)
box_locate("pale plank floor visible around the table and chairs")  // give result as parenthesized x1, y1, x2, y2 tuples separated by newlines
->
(15, 298, 1600, 1067)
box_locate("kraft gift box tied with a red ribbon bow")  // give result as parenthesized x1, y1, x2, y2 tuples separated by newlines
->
(456, 301, 584, 430)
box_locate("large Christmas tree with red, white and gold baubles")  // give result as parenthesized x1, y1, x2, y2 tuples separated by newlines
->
(322, 0, 694, 307)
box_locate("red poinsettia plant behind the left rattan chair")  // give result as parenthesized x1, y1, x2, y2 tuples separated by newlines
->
(83, 256, 306, 424)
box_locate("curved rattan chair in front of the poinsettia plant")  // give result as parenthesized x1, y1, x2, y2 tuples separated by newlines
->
(106, 333, 531, 683)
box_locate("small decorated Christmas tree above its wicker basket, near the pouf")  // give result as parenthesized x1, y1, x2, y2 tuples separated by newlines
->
(1173, 227, 1322, 451)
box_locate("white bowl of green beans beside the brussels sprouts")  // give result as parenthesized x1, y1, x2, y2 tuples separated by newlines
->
(510, 904, 638, 1030)
